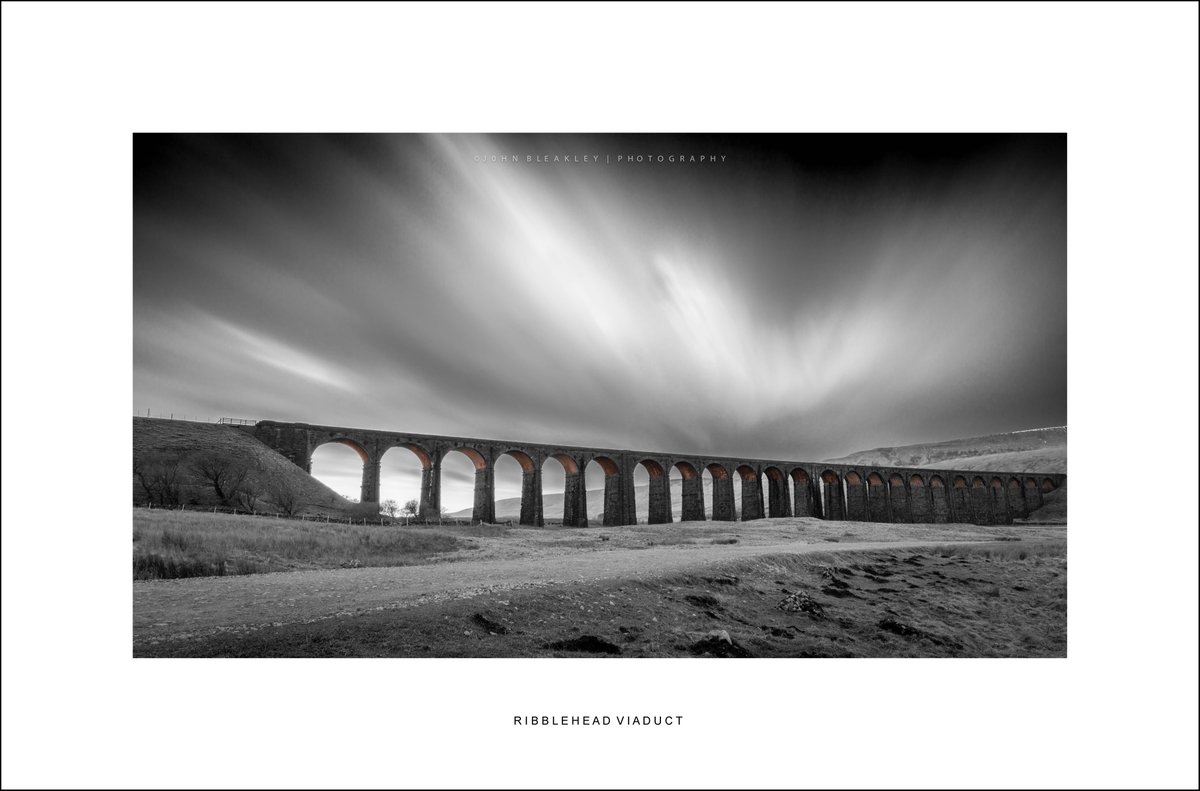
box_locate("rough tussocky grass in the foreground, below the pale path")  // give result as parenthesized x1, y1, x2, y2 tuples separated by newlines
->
(136, 541, 1067, 658)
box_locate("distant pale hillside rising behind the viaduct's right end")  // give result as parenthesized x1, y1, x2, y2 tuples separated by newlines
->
(826, 426, 1067, 473)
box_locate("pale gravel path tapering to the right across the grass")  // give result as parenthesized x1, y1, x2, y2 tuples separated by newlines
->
(133, 539, 1022, 645)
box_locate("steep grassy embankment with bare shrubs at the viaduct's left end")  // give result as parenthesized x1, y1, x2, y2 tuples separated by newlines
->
(133, 418, 353, 514)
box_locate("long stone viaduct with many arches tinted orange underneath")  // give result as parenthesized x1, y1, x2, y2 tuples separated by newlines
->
(245, 420, 1067, 527)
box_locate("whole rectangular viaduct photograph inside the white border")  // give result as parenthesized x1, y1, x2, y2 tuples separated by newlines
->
(132, 134, 1067, 658)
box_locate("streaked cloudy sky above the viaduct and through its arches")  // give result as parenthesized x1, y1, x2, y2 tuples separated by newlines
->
(133, 134, 1067, 510)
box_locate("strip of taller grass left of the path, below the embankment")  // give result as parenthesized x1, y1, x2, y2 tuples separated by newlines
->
(133, 509, 468, 580)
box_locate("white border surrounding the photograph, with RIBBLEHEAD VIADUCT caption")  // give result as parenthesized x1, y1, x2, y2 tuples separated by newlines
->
(2, 2, 1198, 787)
